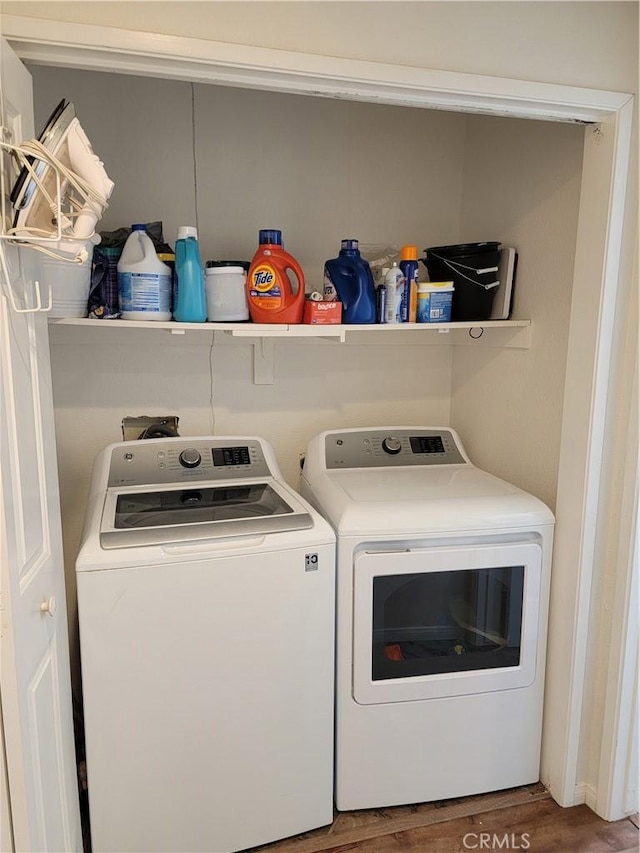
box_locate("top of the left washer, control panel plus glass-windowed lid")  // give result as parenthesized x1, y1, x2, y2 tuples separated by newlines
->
(100, 438, 313, 549)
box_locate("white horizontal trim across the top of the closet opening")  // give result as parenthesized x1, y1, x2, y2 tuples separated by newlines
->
(2, 15, 630, 122)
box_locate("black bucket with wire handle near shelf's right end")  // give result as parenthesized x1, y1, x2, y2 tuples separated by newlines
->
(422, 243, 501, 321)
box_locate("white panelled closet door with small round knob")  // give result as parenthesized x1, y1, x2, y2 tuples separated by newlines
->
(0, 41, 82, 851)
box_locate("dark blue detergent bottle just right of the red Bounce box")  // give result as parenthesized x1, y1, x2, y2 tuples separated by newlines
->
(324, 240, 376, 324)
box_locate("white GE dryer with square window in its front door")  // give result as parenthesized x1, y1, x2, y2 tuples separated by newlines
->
(301, 427, 554, 810)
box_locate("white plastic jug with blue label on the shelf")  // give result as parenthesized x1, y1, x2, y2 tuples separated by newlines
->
(118, 225, 171, 322)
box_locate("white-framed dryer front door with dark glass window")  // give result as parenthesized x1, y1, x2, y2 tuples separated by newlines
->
(354, 543, 541, 704)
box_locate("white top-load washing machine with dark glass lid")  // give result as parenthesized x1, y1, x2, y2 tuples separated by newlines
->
(77, 437, 335, 853)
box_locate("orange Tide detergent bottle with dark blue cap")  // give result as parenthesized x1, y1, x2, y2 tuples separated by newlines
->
(247, 229, 304, 323)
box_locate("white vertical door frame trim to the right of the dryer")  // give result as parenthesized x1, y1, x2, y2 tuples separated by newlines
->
(542, 98, 633, 805)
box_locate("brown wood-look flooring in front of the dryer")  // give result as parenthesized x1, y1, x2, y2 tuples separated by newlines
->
(253, 784, 639, 853)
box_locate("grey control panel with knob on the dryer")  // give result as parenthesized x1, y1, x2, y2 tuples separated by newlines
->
(325, 429, 468, 469)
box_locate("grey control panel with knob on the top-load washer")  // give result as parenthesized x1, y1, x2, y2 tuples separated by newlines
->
(109, 438, 271, 487)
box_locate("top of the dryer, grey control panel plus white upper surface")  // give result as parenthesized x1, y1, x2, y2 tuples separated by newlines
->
(302, 427, 553, 535)
